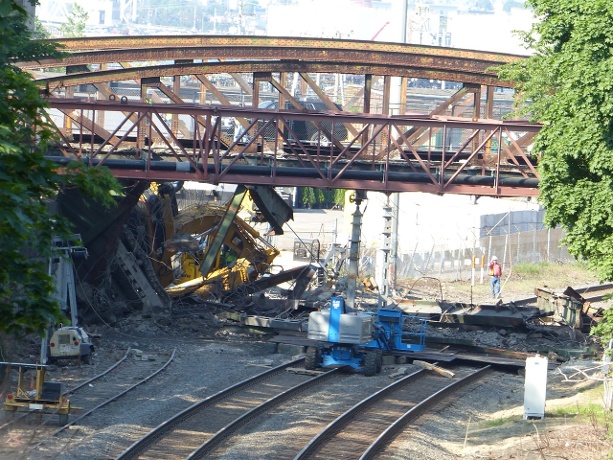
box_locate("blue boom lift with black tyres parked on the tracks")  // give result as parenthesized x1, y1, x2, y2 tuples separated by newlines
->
(305, 297, 426, 376)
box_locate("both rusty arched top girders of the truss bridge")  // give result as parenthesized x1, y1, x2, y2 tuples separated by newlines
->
(20, 36, 524, 88)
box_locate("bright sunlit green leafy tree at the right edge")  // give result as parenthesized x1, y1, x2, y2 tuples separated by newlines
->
(499, 0, 613, 280)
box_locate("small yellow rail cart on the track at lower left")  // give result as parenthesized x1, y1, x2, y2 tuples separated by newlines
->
(0, 362, 71, 425)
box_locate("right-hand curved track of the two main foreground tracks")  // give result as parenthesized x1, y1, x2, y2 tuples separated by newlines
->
(294, 366, 489, 460)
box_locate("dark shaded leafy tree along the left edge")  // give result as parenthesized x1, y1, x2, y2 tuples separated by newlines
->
(0, 1, 119, 334)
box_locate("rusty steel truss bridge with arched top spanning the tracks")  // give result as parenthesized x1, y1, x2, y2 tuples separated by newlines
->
(20, 36, 540, 196)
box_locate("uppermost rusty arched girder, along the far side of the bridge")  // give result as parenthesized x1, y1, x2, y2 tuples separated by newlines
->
(18, 35, 526, 70)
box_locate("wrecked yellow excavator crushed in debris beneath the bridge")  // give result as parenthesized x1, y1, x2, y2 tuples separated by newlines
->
(148, 187, 291, 298)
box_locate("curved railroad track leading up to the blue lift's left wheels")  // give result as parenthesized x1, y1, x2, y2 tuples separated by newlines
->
(116, 358, 338, 460)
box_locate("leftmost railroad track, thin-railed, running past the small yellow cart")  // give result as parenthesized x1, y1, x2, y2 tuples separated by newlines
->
(10, 350, 176, 458)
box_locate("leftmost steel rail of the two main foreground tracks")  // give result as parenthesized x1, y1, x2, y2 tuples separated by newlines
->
(115, 358, 304, 460)
